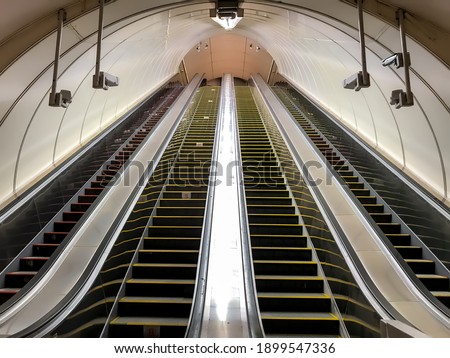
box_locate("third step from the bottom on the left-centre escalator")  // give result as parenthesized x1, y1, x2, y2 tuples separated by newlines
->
(125, 278, 195, 298)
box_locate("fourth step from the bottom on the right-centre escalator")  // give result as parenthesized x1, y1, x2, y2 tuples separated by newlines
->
(253, 260, 317, 276)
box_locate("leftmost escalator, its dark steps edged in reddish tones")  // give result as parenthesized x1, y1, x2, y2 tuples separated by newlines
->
(0, 86, 182, 304)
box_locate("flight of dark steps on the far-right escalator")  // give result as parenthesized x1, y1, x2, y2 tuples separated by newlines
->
(274, 87, 450, 308)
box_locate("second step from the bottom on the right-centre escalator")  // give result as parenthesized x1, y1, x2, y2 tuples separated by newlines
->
(258, 292, 331, 312)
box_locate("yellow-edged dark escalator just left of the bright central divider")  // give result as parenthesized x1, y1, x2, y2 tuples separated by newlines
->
(109, 87, 220, 337)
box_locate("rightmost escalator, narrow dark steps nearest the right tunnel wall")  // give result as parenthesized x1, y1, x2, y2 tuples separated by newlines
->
(274, 87, 450, 308)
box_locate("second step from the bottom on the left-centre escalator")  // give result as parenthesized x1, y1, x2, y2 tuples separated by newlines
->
(118, 296, 192, 318)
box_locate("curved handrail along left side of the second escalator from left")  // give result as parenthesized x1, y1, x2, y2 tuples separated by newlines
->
(7, 76, 201, 337)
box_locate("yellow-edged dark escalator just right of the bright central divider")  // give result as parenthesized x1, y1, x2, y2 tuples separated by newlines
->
(236, 87, 340, 337)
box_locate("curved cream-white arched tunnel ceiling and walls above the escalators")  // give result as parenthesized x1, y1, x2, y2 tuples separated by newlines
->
(0, 0, 450, 208)
